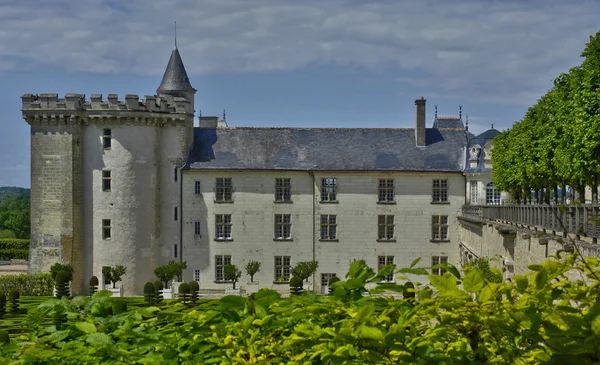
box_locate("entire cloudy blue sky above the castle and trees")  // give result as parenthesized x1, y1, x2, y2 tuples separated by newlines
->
(0, 0, 600, 187)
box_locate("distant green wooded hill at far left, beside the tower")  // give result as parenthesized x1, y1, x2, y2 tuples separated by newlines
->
(0, 186, 31, 238)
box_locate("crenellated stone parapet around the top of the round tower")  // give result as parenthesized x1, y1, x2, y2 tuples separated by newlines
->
(21, 94, 194, 125)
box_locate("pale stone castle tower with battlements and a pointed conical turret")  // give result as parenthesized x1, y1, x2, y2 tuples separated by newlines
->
(22, 47, 196, 295)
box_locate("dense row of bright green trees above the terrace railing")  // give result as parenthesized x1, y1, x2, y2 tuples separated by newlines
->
(492, 32, 600, 203)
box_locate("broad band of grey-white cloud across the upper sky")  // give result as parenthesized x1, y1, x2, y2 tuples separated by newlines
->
(0, 0, 600, 105)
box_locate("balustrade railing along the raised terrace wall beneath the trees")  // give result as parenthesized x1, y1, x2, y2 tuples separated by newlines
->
(461, 204, 600, 238)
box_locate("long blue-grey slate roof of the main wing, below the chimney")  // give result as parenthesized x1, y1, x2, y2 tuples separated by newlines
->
(185, 127, 467, 172)
